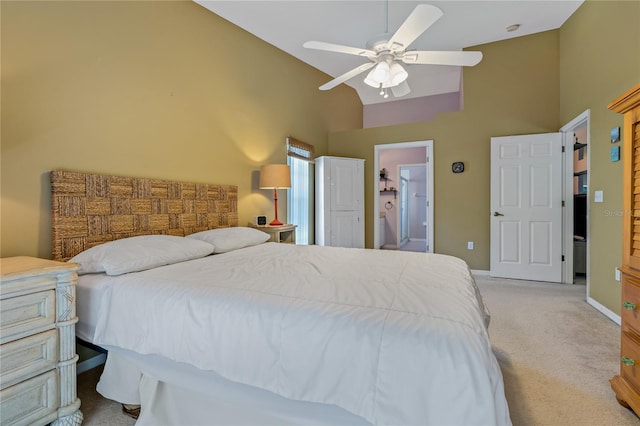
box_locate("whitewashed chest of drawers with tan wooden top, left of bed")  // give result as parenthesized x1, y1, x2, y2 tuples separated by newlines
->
(0, 256, 82, 426)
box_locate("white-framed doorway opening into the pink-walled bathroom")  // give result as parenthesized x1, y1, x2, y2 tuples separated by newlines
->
(373, 140, 433, 252)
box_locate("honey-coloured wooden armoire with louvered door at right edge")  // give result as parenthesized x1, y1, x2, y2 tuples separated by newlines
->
(609, 84, 640, 414)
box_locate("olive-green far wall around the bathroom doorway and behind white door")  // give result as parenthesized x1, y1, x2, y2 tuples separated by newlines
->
(329, 30, 560, 270)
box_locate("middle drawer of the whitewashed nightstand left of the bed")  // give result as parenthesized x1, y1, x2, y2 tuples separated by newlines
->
(0, 330, 58, 389)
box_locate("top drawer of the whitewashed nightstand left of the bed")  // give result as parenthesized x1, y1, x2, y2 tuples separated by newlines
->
(0, 290, 56, 343)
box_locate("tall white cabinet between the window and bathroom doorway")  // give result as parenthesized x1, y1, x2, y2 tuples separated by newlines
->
(315, 157, 364, 248)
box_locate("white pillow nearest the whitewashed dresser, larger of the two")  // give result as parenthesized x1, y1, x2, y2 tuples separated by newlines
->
(69, 235, 214, 275)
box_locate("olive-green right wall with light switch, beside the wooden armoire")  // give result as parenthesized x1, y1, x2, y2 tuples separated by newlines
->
(560, 1, 640, 314)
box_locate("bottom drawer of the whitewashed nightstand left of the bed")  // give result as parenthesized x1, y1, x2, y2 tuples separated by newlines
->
(0, 370, 58, 425)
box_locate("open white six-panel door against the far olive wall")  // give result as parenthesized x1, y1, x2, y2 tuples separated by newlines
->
(490, 133, 563, 282)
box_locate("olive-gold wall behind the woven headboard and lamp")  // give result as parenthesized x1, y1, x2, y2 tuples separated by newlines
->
(0, 1, 362, 258)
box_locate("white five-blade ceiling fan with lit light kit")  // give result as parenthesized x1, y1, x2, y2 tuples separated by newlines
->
(303, 3, 482, 98)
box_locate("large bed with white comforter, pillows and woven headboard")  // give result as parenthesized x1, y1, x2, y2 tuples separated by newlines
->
(51, 171, 511, 425)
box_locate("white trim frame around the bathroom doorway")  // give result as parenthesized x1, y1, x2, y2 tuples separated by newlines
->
(372, 139, 435, 253)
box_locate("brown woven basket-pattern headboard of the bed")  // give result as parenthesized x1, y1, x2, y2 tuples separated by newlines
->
(51, 170, 238, 261)
